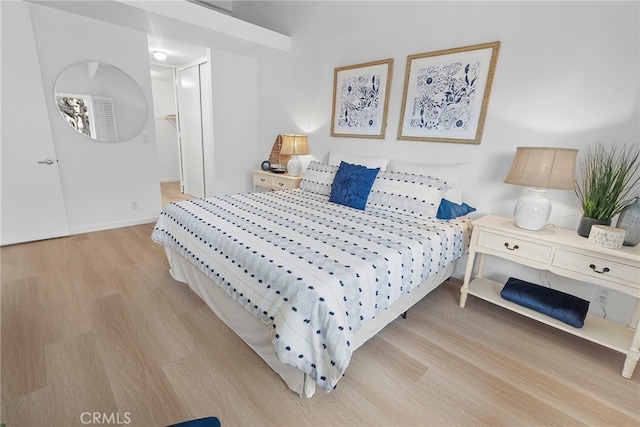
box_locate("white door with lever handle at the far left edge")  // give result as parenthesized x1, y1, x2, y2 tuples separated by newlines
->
(0, 2, 69, 245)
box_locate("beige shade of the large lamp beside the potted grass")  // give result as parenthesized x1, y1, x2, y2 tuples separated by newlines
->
(504, 147, 578, 190)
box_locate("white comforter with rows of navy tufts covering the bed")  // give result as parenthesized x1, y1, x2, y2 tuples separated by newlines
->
(152, 190, 471, 392)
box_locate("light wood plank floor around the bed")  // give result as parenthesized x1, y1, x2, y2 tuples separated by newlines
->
(0, 185, 640, 427)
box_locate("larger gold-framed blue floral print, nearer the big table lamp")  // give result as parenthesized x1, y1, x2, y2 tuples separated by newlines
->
(398, 41, 500, 144)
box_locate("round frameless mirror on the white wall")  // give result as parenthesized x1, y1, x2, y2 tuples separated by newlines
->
(55, 62, 147, 142)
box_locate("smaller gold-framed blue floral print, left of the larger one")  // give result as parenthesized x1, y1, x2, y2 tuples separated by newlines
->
(331, 58, 393, 139)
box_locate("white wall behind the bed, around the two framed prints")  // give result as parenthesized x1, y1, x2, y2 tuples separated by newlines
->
(234, 1, 640, 323)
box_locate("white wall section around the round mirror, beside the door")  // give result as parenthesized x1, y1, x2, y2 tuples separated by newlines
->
(29, 4, 161, 234)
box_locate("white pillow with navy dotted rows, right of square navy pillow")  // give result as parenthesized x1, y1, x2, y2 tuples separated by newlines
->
(367, 171, 449, 218)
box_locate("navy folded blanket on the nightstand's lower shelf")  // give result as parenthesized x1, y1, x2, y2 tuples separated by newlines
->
(500, 277, 589, 328)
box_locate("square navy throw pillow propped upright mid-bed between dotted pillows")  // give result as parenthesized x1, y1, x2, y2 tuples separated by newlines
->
(329, 162, 380, 210)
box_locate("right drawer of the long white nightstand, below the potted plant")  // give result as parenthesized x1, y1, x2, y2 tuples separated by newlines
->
(553, 249, 640, 289)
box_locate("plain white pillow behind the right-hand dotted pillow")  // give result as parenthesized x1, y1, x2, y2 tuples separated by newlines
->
(388, 159, 473, 205)
